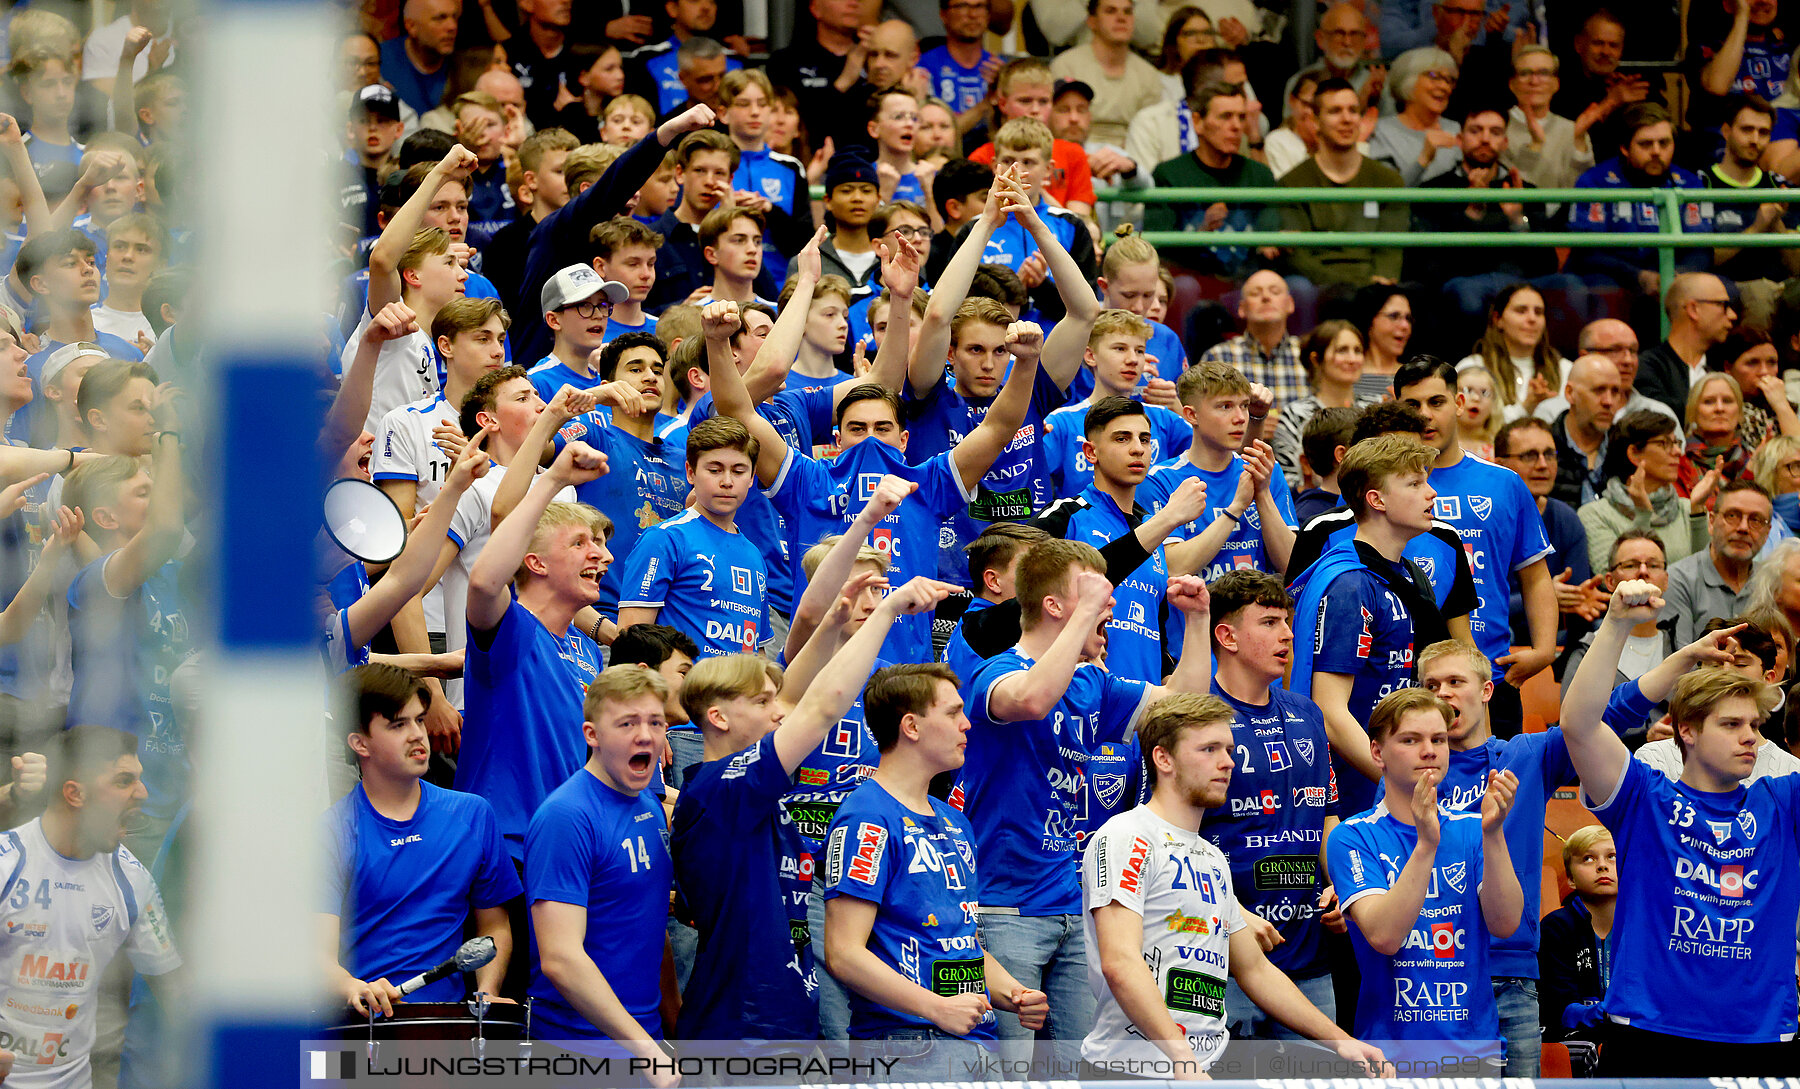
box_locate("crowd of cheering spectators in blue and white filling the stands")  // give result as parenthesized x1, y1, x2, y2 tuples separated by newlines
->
(0, 0, 1800, 1089)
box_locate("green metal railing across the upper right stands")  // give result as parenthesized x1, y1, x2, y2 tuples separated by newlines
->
(1096, 187, 1800, 333)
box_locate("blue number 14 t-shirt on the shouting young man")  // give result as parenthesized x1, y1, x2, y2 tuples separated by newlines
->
(525, 765, 675, 1040)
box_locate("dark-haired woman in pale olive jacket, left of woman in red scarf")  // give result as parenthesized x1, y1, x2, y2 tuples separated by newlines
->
(1577, 409, 1717, 571)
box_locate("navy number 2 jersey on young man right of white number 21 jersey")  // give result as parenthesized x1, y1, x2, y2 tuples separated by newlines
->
(1201, 679, 1337, 979)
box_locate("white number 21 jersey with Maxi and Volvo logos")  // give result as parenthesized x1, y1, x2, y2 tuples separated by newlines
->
(1082, 805, 1244, 1076)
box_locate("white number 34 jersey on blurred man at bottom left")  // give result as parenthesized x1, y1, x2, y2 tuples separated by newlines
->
(0, 819, 182, 1089)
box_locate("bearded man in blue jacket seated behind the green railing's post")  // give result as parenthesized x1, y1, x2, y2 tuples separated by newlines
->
(1570, 103, 1712, 297)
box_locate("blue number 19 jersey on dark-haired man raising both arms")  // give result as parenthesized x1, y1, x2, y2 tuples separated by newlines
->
(763, 439, 974, 662)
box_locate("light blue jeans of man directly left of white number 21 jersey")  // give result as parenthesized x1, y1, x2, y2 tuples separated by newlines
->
(976, 913, 1094, 1067)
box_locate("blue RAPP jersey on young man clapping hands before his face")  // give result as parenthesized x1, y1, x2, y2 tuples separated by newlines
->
(1325, 803, 1497, 1049)
